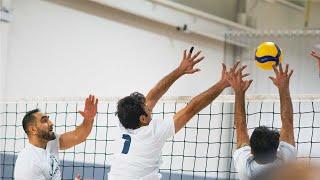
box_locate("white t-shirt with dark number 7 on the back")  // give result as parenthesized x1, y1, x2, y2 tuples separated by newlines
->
(108, 119, 175, 180)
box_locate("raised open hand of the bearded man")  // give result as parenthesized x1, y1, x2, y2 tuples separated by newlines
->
(79, 95, 98, 121)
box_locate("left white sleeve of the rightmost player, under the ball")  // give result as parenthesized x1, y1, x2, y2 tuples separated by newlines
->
(233, 146, 251, 172)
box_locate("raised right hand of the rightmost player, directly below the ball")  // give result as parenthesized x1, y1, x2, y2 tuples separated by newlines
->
(269, 63, 293, 89)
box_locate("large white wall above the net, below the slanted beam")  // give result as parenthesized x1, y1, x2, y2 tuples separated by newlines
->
(5, 0, 223, 97)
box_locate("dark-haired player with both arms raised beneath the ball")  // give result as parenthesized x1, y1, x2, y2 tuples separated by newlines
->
(228, 64, 297, 179)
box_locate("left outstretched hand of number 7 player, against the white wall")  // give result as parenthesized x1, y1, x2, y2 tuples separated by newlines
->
(179, 47, 204, 74)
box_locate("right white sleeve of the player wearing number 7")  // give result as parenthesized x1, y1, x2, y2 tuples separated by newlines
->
(152, 119, 175, 141)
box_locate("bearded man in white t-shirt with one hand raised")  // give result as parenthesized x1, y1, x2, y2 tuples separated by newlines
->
(14, 95, 98, 180)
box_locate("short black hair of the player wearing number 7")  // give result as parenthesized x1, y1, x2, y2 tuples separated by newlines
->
(116, 92, 147, 129)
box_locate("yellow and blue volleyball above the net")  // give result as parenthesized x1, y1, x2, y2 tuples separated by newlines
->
(255, 42, 283, 70)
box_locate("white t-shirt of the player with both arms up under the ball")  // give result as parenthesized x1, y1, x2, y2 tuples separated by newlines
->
(233, 141, 297, 180)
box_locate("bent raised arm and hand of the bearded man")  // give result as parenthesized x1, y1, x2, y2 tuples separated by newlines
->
(59, 95, 98, 150)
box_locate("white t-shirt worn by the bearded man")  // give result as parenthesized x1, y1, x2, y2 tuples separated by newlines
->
(14, 134, 61, 180)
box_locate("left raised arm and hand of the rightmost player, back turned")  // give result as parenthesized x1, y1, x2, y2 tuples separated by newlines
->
(227, 66, 252, 148)
